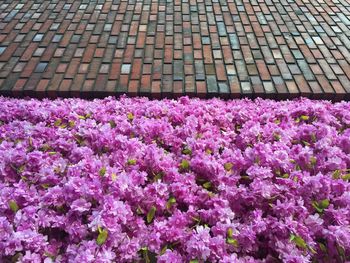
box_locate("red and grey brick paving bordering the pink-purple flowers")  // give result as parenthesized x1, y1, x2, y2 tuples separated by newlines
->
(0, 0, 350, 99)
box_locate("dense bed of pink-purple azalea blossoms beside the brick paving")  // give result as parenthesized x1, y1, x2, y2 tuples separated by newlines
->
(0, 97, 350, 263)
